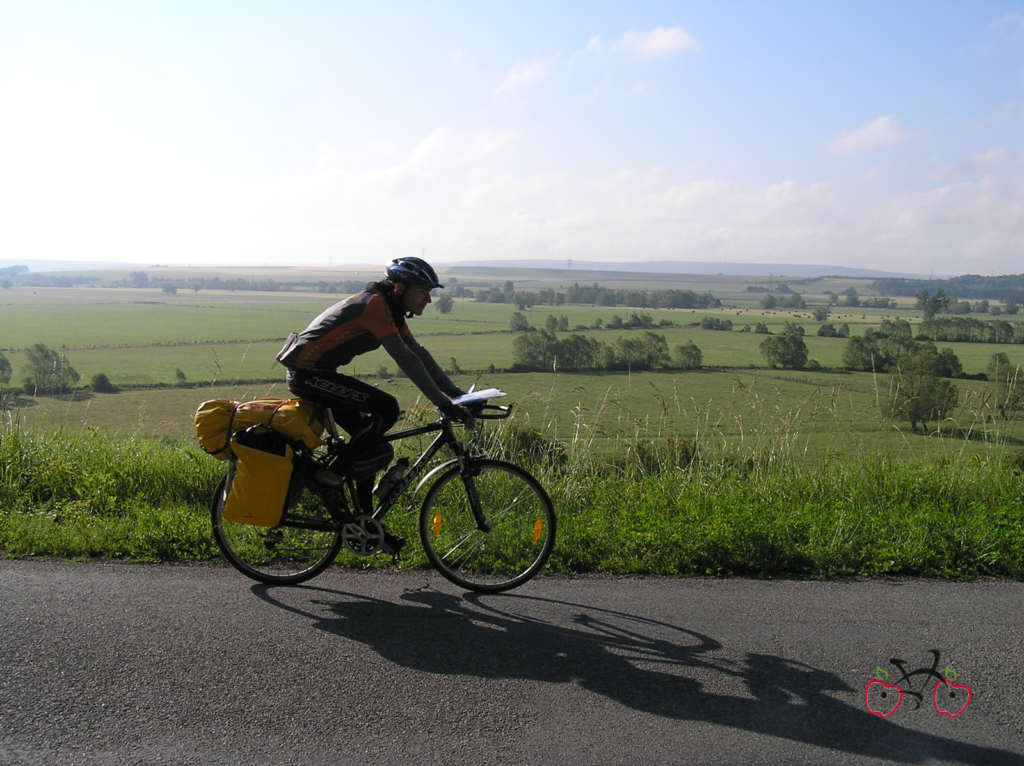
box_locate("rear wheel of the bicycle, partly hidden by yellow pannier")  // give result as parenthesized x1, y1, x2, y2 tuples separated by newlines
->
(210, 476, 342, 585)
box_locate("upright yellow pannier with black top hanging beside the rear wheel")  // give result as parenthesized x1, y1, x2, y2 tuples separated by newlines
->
(221, 425, 294, 526)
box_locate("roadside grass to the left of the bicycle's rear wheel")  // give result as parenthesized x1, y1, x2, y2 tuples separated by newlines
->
(0, 424, 222, 560)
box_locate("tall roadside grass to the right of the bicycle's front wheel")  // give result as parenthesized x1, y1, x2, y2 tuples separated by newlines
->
(471, 380, 1024, 578)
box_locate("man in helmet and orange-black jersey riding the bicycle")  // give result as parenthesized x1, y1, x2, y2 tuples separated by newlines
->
(278, 257, 472, 528)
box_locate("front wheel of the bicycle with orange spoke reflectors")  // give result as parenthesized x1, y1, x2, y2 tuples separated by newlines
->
(420, 460, 555, 593)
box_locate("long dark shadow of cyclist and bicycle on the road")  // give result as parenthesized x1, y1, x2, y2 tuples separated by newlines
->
(253, 586, 1022, 766)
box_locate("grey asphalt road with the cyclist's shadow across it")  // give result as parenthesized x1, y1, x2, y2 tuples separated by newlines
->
(0, 561, 1024, 766)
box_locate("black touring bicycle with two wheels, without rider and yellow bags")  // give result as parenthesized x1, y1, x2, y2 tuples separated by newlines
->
(211, 403, 556, 593)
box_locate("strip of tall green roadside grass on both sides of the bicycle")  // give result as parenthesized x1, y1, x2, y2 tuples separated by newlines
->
(0, 384, 1024, 578)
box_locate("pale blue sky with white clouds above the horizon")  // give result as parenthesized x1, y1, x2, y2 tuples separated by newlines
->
(0, 0, 1024, 275)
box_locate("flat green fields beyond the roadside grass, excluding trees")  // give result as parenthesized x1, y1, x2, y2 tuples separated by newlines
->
(0, 269, 1024, 457)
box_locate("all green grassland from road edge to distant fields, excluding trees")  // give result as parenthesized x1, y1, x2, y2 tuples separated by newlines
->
(0, 270, 1024, 577)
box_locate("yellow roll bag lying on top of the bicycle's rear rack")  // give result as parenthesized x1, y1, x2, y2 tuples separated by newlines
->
(193, 398, 324, 460)
